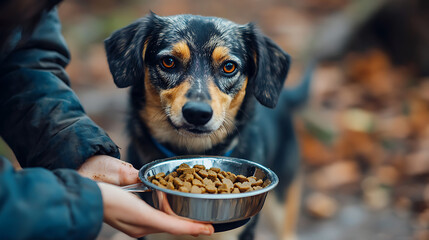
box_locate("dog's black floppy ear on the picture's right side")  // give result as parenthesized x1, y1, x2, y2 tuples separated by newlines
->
(245, 24, 291, 108)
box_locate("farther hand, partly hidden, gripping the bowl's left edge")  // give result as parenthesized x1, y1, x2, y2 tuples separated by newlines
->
(77, 155, 140, 186)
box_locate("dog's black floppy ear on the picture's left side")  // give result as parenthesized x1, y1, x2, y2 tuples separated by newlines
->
(104, 14, 153, 88)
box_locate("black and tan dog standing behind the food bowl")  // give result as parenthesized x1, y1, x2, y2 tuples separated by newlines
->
(105, 13, 309, 239)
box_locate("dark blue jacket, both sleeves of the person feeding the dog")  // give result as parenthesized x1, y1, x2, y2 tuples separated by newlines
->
(0, 10, 119, 239)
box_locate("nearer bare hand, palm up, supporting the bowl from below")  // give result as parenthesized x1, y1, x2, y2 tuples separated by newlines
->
(98, 182, 214, 238)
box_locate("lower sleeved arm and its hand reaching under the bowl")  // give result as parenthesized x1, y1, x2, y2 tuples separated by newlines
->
(0, 157, 214, 240)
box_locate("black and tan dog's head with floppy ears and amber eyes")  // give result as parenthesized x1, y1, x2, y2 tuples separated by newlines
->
(105, 14, 290, 152)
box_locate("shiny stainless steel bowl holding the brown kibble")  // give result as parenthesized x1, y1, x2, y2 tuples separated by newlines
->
(125, 156, 278, 223)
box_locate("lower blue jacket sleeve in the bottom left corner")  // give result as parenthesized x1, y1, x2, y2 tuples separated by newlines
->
(0, 157, 103, 240)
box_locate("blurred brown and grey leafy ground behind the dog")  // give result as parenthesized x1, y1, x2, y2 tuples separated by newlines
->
(0, 0, 429, 240)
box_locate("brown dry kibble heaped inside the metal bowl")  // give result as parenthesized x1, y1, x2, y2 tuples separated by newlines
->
(148, 163, 271, 194)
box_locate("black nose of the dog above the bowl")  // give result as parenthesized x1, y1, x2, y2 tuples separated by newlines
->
(182, 102, 213, 126)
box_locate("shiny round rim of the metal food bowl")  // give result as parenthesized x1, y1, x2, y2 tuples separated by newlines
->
(139, 155, 279, 200)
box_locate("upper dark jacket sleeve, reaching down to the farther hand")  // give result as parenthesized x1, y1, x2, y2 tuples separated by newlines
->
(0, 9, 119, 169)
